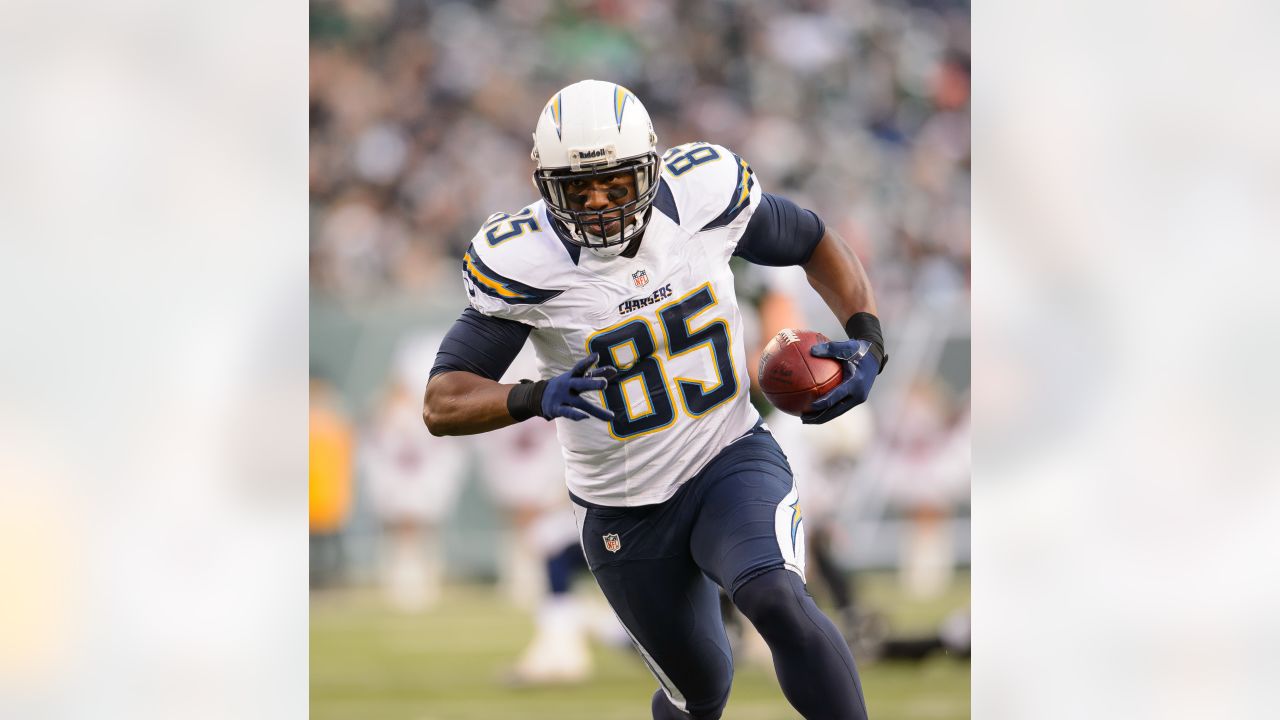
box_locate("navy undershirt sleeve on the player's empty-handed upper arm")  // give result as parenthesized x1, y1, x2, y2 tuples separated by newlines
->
(430, 307, 532, 380)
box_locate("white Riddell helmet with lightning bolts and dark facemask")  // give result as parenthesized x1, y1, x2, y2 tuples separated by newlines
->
(531, 79, 662, 255)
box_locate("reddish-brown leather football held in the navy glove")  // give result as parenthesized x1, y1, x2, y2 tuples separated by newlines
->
(758, 328, 842, 415)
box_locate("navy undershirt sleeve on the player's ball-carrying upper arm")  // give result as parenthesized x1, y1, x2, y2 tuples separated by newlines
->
(733, 192, 827, 268)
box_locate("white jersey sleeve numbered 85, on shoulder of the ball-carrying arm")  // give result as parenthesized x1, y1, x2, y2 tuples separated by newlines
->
(663, 142, 763, 259)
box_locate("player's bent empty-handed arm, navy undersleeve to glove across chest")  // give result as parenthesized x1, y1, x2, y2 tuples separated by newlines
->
(422, 307, 617, 436)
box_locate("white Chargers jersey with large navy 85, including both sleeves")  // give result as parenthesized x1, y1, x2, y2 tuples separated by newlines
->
(462, 142, 762, 506)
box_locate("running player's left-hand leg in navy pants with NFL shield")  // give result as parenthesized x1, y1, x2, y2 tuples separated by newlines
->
(575, 499, 733, 710)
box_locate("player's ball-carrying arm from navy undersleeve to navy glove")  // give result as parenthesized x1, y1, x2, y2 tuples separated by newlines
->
(735, 193, 887, 424)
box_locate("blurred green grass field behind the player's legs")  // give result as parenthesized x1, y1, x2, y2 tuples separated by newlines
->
(311, 577, 969, 720)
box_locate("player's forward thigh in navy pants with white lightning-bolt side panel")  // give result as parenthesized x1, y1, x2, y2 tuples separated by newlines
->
(690, 433, 804, 597)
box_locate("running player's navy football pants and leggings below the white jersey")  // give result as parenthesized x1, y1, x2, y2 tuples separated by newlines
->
(573, 432, 867, 720)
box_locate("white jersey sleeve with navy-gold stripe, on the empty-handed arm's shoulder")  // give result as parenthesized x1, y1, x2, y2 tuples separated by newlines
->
(462, 217, 564, 328)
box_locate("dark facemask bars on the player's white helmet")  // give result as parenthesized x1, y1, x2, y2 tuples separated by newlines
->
(534, 152, 660, 255)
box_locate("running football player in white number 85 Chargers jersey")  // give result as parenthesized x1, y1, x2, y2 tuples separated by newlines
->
(422, 81, 886, 720)
